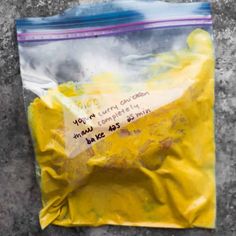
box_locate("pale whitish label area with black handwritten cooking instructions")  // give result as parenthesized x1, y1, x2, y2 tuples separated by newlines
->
(64, 81, 193, 158)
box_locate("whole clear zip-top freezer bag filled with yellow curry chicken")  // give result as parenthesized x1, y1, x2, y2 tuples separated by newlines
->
(16, 1, 216, 228)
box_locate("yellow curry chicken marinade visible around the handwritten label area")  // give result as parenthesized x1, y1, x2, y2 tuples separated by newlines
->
(28, 29, 216, 228)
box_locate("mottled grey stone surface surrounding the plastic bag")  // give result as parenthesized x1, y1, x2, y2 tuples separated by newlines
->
(0, 0, 236, 236)
